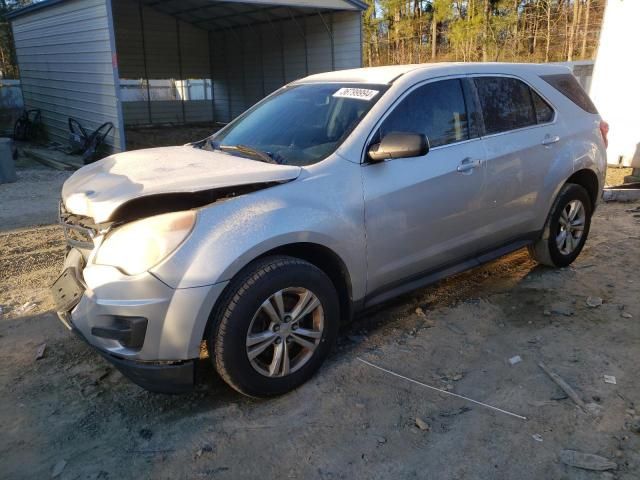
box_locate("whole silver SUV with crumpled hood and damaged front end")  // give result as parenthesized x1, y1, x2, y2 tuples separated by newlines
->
(52, 64, 608, 396)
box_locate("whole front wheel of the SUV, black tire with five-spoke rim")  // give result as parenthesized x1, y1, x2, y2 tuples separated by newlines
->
(208, 256, 339, 397)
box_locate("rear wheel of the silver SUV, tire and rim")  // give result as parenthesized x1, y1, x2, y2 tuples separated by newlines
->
(529, 183, 593, 267)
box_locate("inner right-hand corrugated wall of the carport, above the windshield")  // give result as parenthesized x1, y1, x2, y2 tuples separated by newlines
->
(211, 12, 362, 122)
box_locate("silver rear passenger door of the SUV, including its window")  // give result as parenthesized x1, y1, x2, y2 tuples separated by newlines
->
(473, 75, 566, 250)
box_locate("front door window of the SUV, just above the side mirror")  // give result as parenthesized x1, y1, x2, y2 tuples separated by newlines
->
(377, 79, 469, 148)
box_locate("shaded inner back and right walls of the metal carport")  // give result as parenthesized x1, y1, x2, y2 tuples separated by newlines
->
(112, 0, 362, 125)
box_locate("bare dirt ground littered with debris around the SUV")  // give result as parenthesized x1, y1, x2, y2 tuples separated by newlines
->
(0, 162, 640, 480)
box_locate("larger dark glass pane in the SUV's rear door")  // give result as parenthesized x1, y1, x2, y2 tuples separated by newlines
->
(474, 77, 538, 135)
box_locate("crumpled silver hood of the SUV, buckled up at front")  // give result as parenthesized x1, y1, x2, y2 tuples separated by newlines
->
(62, 146, 301, 223)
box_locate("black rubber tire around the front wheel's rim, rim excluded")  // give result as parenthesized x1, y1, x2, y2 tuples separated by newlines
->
(207, 256, 340, 397)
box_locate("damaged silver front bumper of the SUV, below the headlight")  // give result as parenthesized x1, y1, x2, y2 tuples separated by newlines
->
(52, 248, 226, 393)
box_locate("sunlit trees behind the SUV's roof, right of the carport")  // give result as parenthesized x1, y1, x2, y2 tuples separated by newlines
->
(364, 0, 605, 65)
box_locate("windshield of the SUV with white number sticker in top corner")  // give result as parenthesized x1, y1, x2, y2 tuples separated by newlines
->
(205, 83, 386, 166)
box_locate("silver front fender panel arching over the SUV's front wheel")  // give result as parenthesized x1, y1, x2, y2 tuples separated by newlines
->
(153, 160, 366, 298)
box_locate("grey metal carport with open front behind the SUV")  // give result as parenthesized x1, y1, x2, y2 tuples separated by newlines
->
(10, 0, 366, 151)
